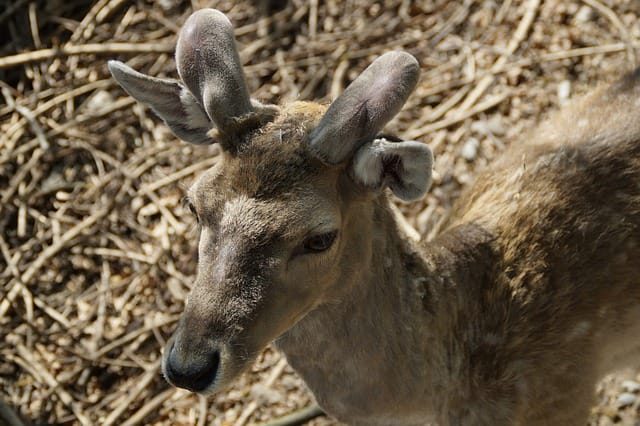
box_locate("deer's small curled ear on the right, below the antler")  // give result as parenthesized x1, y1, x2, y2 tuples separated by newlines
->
(351, 139, 433, 201)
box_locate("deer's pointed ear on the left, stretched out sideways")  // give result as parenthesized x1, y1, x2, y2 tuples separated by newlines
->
(107, 61, 216, 145)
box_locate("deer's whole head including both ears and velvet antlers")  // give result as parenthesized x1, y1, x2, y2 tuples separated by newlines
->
(109, 9, 432, 393)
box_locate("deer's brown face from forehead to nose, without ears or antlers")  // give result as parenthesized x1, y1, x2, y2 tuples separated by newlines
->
(164, 108, 342, 391)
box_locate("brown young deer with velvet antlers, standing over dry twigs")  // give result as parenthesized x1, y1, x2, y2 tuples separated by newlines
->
(109, 9, 640, 426)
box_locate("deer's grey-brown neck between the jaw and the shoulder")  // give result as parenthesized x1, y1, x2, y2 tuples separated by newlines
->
(277, 200, 450, 423)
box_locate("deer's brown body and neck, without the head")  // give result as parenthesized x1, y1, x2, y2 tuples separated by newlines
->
(278, 77, 640, 425)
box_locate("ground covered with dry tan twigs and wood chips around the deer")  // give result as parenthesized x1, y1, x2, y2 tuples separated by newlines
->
(0, 0, 640, 426)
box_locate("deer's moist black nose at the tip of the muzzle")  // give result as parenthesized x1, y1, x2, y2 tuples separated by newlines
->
(164, 341, 220, 392)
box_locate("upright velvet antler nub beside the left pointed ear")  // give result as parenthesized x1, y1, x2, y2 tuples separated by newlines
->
(176, 9, 253, 133)
